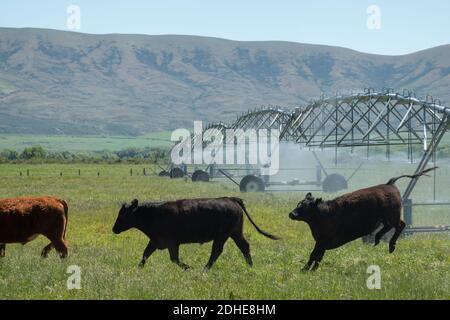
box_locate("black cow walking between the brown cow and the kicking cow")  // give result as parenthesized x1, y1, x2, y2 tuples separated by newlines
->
(112, 198, 278, 269)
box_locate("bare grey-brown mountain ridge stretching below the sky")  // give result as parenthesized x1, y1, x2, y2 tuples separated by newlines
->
(0, 28, 450, 135)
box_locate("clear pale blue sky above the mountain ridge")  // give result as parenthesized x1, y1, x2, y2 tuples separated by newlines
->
(0, 0, 450, 54)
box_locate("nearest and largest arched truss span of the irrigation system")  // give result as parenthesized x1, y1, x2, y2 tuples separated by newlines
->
(289, 92, 450, 148)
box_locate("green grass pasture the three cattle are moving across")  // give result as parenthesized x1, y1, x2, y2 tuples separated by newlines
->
(0, 165, 450, 299)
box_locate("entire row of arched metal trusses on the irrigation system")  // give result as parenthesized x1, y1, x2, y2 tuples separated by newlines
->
(193, 89, 450, 199)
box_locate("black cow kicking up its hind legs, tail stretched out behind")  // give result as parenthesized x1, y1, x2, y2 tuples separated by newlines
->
(289, 168, 436, 271)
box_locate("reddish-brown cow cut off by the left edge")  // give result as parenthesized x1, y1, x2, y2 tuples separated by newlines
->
(0, 197, 68, 258)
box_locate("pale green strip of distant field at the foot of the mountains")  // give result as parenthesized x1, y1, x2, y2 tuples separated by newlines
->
(0, 131, 173, 152)
